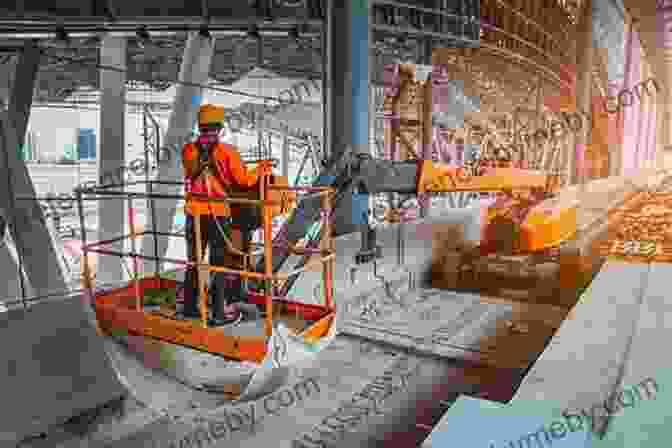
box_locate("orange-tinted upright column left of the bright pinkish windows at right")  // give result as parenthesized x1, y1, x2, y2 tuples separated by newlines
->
(570, 0, 594, 184)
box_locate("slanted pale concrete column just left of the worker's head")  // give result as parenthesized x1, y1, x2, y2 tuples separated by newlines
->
(142, 33, 215, 272)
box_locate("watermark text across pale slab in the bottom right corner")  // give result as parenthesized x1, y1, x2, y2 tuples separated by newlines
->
(489, 378, 659, 448)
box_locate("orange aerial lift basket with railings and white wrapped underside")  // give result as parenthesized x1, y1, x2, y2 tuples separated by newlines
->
(78, 161, 336, 400)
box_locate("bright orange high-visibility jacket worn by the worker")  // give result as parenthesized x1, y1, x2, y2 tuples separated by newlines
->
(182, 143, 259, 216)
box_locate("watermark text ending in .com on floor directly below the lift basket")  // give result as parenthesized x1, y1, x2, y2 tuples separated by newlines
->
(167, 378, 321, 448)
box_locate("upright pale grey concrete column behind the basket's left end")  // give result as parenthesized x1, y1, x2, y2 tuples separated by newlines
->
(97, 36, 128, 282)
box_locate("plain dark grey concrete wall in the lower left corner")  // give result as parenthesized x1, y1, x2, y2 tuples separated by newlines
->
(0, 297, 126, 447)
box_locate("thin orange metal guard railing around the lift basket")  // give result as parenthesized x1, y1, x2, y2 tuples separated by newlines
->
(77, 174, 335, 336)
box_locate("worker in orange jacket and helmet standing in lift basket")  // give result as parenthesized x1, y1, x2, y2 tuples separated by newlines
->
(182, 104, 259, 325)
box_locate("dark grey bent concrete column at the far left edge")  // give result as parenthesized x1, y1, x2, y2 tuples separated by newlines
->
(0, 41, 68, 296)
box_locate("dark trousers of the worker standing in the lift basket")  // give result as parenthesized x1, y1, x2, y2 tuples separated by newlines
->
(184, 215, 243, 318)
